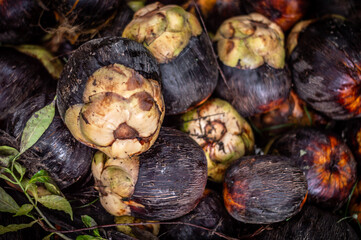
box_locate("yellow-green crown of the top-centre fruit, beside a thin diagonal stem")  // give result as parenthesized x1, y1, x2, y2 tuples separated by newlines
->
(123, 3, 202, 63)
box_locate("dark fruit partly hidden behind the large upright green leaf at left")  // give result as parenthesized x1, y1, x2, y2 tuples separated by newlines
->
(6, 92, 93, 189)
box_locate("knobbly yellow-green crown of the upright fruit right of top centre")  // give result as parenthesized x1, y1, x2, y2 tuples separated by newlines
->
(214, 13, 285, 69)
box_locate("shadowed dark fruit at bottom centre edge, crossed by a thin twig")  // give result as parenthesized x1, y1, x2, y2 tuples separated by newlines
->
(159, 189, 236, 240)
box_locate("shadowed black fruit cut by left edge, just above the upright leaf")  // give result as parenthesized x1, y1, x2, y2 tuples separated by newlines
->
(0, 47, 56, 120)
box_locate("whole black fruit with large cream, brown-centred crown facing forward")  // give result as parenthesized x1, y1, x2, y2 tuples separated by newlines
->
(58, 38, 164, 158)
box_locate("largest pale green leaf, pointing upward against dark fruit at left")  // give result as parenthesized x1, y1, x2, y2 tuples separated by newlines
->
(20, 100, 55, 153)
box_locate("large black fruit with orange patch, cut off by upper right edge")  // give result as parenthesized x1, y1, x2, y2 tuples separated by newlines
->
(290, 16, 361, 120)
